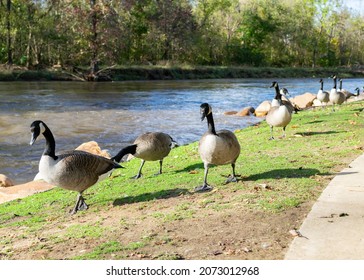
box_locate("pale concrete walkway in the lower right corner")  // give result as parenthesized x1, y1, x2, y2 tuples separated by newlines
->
(285, 154, 364, 260)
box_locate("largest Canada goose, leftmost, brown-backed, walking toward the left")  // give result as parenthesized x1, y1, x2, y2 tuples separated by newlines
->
(30, 120, 122, 214)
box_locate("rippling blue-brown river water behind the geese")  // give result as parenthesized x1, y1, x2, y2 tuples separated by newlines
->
(0, 78, 364, 184)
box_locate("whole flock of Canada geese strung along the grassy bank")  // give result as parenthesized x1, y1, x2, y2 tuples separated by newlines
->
(30, 75, 360, 214)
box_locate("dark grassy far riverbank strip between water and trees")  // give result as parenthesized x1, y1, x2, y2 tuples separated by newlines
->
(0, 66, 364, 81)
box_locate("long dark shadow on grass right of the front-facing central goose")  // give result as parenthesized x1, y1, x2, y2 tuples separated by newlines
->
(244, 168, 324, 181)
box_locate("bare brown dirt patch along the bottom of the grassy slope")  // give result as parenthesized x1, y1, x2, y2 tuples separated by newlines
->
(0, 189, 310, 260)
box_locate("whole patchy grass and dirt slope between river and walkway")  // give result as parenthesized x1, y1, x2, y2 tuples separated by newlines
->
(0, 102, 364, 259)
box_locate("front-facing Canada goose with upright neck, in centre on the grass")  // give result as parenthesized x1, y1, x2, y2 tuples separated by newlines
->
(195, 103, 240, 192)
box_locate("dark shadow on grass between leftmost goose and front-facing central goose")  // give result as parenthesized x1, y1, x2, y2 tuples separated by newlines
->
(113, 189, 189, 206)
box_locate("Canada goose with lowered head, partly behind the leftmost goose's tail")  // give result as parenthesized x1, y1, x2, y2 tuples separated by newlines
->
(111, 132, 177, 179)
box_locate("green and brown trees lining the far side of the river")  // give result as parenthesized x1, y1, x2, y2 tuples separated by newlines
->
(0, 0, 364, 71)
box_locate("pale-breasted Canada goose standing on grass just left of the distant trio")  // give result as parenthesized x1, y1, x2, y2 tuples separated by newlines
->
(266, 82, 292, 140)
